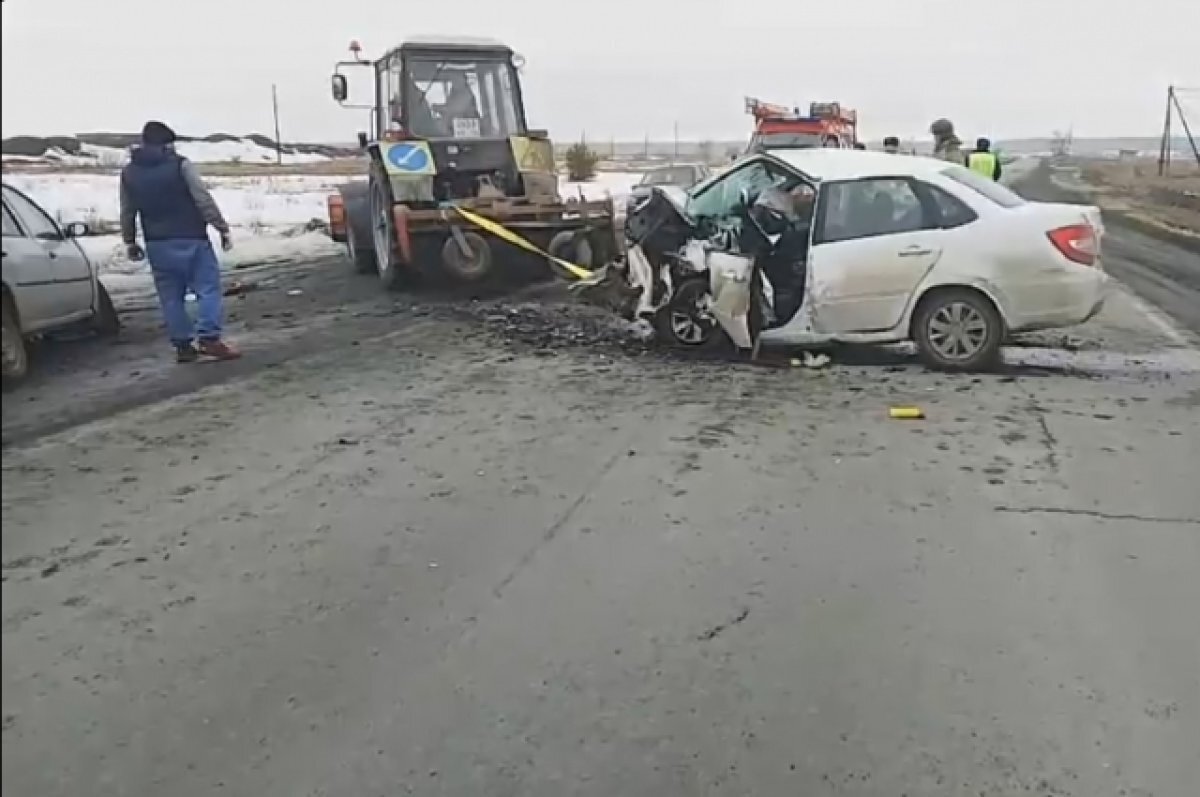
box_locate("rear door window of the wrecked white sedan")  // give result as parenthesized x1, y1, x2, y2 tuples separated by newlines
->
(816, 178, 940, 244)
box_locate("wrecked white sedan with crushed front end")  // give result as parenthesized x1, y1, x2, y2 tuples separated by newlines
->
(628, 149, 1108, 370)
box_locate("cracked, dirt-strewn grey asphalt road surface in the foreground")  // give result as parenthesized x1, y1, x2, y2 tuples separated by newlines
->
(2, 246, 1200, 797)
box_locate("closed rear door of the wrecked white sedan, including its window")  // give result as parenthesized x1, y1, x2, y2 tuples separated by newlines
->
(809, 178, 942, 334)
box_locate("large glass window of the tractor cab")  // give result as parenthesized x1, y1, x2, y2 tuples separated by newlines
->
(404, 59, 522, 138)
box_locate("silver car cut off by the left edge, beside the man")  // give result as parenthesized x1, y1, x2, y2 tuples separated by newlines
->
(2, 185, 120, 386)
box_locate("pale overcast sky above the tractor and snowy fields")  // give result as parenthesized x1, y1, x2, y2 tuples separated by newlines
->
(0, 0, 1200, 142)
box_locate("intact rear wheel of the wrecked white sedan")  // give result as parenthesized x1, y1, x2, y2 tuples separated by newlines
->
(912, 288, 1004, 371)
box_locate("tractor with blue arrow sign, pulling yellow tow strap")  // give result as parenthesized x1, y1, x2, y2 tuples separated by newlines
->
(329, 38, 617, 288)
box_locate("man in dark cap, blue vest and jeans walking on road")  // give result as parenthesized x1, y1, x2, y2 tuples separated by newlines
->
(120, 121, 240, 362)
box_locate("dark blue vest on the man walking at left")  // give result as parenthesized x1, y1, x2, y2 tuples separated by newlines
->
(121, 145, 208, 241)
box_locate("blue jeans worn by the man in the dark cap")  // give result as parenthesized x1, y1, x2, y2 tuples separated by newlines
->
(146, 238, 221, 346)
